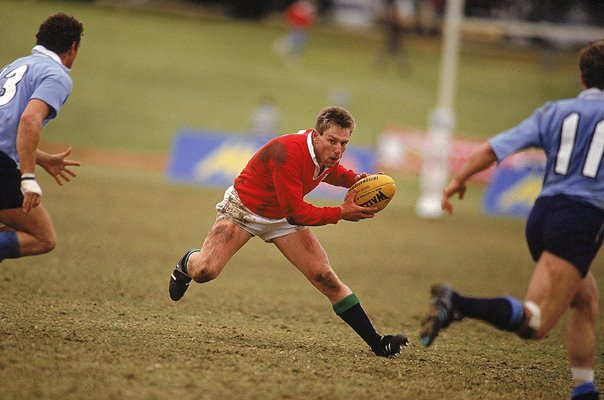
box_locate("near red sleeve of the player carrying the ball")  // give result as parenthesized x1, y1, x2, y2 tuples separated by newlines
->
(271, 147, 342, 226)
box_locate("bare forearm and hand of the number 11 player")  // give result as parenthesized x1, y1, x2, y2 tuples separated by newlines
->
(440, 142, 497, 214)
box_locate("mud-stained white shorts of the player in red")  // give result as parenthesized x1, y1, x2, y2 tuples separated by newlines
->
(216, 186, 307, 242)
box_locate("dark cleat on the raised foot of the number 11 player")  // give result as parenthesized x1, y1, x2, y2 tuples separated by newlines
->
(420, 284, 461, 347)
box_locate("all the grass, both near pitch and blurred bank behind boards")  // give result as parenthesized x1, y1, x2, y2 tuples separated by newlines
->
(0, 0, 604, 400)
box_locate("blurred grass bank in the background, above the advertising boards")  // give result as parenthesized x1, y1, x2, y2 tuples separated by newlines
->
(0, 0, 578, 152)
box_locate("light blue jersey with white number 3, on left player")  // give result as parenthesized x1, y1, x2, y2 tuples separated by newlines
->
(0, 46, 73, 164)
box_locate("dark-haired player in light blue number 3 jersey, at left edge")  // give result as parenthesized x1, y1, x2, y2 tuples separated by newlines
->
(0, 13, 83, 261)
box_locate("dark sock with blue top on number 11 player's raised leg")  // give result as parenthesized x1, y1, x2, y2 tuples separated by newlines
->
(453, 293, 524, 332)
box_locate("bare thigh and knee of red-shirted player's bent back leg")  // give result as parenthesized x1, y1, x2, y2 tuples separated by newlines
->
(187, 220, 252, 283)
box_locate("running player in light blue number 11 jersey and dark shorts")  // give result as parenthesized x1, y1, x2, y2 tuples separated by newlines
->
(420, 40, 604, 400)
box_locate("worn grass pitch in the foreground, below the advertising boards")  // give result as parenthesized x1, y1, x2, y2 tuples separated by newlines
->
(0, 167, 604, 400)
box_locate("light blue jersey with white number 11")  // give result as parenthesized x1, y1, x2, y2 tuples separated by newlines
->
(489, 88, 604, 210)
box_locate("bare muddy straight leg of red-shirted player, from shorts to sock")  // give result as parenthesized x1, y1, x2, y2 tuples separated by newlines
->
(274, 229, 352, 303)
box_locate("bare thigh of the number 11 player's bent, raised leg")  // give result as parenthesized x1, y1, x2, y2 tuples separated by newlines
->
(525, 251, 583, 338)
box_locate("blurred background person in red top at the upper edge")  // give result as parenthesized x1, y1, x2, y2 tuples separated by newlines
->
(274, 0, 317, 66)
